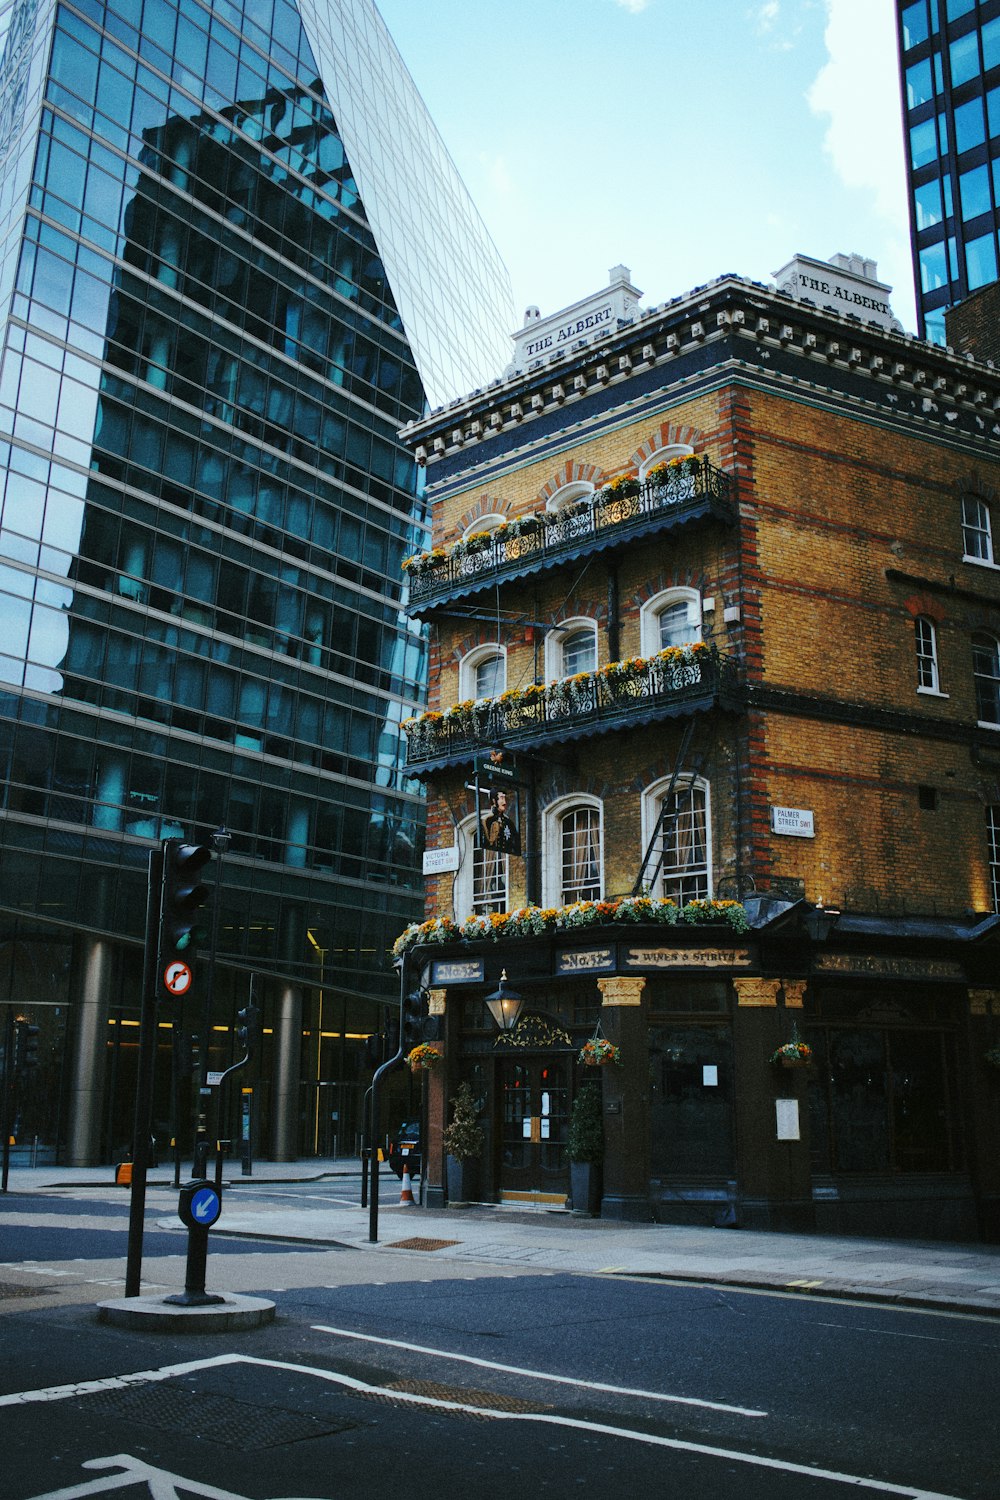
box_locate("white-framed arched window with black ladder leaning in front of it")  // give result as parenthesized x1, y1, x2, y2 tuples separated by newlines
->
(643, 777, 712, 906)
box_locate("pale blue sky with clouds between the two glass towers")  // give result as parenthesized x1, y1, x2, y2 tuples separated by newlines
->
(376, 0, 916, 332)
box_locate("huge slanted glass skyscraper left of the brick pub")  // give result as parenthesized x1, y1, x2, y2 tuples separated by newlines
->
(0, 0, 513, 1163)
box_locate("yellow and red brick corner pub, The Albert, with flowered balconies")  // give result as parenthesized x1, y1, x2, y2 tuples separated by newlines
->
(397, 267, 1000, 1239)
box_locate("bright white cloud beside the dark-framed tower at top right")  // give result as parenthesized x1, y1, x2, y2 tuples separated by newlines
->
(807, 0, 907, 227)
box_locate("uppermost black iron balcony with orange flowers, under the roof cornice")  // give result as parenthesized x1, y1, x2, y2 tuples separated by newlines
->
(406, 459, 736, 615)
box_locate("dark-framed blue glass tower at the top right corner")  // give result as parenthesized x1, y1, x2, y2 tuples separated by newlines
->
(897, 0, 1000, 344)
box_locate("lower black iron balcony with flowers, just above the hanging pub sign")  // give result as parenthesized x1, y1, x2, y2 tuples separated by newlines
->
(403, 644, 742, 774)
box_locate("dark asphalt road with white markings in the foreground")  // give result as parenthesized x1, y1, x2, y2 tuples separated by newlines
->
(0, 1179, 1000, 1500)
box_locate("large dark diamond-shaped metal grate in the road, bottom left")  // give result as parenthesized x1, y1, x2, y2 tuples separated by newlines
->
(76, 1382, 361, 1451)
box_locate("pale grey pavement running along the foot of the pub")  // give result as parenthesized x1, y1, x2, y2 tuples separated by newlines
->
(7, 1158, 1000, 1317)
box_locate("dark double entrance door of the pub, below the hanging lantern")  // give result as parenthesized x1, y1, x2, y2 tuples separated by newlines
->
(499, 1053, 571, 1203)
